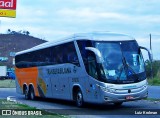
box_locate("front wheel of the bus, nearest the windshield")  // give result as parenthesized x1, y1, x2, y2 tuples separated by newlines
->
(75, 89, 84, 107)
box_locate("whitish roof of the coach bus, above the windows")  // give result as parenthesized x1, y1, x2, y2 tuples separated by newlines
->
(16, 32, 135, 55)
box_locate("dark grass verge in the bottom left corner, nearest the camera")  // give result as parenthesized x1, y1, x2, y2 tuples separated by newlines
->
(0, 99, 64, 118)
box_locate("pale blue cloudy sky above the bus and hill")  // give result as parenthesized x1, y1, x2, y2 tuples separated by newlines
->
(0, 0, 160, 59)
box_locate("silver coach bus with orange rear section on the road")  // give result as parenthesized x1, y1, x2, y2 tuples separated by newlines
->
(15, 33, 151, 107)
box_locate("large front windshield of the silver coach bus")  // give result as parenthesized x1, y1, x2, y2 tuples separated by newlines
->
(95, 41, 146, 84)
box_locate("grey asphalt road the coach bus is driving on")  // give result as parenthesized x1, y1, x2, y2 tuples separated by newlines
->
(0, 86, 160, 118)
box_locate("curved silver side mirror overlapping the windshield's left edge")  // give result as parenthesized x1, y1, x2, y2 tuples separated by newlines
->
(85, 47, 103, 63)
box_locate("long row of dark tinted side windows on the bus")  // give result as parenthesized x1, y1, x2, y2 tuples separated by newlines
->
(15, 42, 79, 68)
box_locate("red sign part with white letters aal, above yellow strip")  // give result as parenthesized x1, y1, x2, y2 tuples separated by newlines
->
(0, 0, 17, 10)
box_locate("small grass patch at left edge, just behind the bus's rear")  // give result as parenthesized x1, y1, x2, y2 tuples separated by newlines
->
(0, 79, 16, 88)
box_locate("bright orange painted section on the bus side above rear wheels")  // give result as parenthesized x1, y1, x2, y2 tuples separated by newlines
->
(15, 67, 39, 96)
